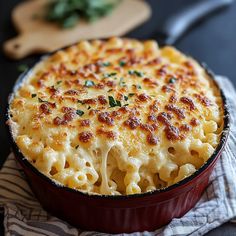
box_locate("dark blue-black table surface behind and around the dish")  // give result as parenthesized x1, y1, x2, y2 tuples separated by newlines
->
(0, 0, 236, 236)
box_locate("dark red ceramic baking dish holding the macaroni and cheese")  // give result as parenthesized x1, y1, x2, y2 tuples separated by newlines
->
(7, 44, 229, 233)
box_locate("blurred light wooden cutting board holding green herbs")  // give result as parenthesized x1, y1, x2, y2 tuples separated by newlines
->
(3, 0, 151, 59)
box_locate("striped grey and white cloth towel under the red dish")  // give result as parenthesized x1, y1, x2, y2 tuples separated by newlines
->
(0, 76, 236, 236)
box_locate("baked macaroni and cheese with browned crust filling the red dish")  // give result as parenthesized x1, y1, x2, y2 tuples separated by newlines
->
(10, 38, 223, 194)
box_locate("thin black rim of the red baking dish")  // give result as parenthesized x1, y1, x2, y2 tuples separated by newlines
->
(5, 39, 230, 200)
